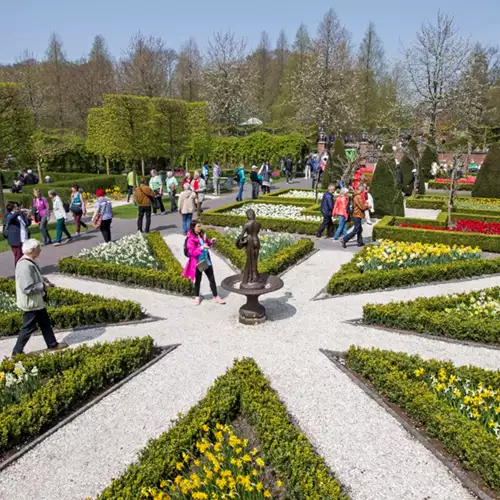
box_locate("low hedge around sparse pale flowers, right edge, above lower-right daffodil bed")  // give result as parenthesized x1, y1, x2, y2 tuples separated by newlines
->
(363, 288, 500, 344)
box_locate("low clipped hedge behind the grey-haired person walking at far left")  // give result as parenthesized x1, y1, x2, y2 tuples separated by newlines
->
(0, 278, 144, 335)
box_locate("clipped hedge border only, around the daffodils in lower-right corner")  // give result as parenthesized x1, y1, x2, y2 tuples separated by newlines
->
(347, 346, 500, 492)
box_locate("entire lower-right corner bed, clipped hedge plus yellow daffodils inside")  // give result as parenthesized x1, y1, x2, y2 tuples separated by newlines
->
(347, 347, 500, 493)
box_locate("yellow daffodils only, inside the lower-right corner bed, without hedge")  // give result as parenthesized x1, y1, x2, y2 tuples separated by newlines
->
(414, 368, 500, 439)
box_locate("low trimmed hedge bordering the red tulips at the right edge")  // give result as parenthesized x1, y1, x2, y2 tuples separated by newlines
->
(373, 214, 500, 253)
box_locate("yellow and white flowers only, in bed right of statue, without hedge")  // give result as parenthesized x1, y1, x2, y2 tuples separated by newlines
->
(356, 240, 481, 272)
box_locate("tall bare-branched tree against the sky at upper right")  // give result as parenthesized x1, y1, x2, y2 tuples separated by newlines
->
(404, 12, 469, 139)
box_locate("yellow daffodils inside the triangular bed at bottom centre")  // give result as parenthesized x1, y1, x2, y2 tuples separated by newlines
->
(142, 424, 282, 500)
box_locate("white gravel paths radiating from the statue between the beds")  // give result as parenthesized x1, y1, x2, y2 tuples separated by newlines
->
(0, 236, 500, 500)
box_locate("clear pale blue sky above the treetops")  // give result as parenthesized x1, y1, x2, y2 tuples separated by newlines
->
(0, 0, 500, 63)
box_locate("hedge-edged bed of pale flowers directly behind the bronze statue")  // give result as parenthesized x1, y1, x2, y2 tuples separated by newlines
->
(207, 229, 314, 274)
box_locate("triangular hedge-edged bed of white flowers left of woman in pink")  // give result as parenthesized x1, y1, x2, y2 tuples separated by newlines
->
(58, 232, 193, 295)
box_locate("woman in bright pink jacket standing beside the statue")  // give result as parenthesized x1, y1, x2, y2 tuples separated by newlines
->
(182, 220, 225, 305)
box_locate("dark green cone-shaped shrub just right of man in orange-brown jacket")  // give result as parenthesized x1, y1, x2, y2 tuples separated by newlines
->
(370, 146, 405, 217)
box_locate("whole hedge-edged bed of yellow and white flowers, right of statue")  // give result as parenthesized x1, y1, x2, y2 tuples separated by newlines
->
(327, 241, 500, 295)
